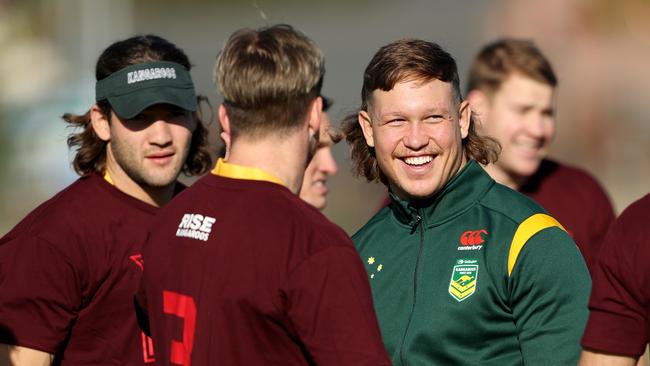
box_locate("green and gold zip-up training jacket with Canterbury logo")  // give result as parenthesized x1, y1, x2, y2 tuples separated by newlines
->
(353, 161, 591, 366)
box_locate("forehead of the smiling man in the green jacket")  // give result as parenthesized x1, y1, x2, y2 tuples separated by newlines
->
(369, 79, 454, 115)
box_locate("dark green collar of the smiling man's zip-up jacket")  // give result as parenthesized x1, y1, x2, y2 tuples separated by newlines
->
(389, 160, 495, 227)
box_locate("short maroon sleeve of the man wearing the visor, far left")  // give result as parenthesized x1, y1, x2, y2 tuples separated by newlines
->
(0, 235, 82, 353)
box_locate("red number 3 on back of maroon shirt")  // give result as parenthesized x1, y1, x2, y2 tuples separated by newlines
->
(163, 290, 196, 366)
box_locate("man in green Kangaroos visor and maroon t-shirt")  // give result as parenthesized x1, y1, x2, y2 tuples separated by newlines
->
(0, 35, 212, 365)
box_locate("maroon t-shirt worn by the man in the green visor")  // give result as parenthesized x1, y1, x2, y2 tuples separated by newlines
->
(0, 175, 157, 365)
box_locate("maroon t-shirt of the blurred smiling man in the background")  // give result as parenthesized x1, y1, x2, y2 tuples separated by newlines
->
(520, 159, 615, 271)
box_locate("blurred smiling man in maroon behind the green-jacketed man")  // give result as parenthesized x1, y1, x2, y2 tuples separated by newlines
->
(467, 39, 614, 269)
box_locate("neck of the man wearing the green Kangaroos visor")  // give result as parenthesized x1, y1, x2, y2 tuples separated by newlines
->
(106, 159, 176, 207)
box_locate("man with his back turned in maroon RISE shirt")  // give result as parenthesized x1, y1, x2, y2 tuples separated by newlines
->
(137, 25, 390, 366)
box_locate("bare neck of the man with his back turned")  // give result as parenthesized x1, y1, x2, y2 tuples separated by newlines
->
(227, 129, 309, 194)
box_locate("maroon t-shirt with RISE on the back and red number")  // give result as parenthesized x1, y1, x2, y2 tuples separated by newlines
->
(138, 174, 390, 366)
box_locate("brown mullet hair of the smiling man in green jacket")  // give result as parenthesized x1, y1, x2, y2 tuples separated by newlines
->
(341, 39, 501, 185)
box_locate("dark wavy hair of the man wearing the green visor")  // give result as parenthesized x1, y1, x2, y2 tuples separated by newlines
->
(62, 34, 212, 176)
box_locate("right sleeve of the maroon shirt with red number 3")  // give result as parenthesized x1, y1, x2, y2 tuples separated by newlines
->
(284, 244, 390, 366)
